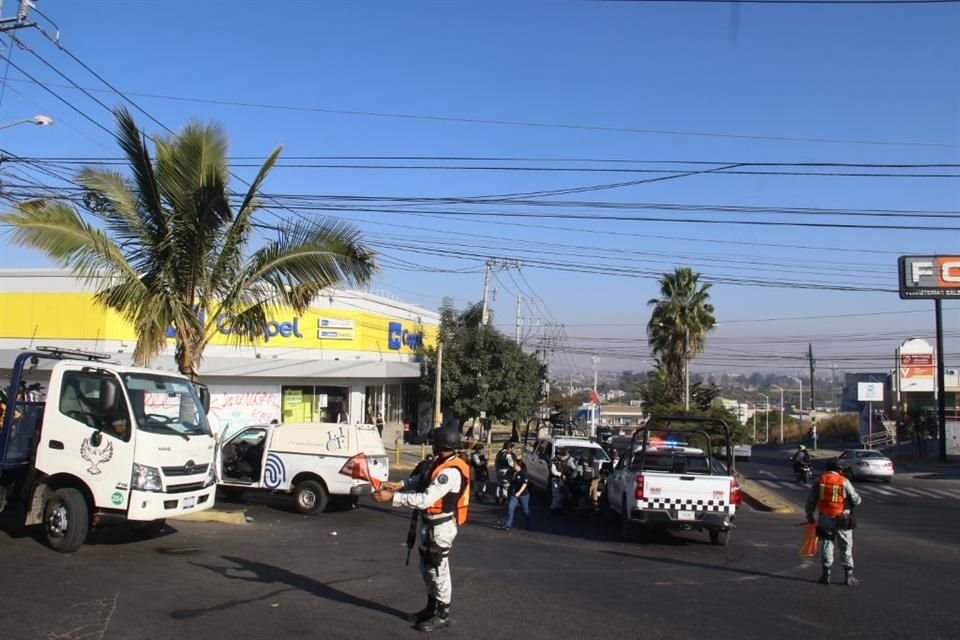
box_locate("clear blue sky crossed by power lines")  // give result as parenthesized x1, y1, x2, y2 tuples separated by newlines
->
(0, 0, 960, 372)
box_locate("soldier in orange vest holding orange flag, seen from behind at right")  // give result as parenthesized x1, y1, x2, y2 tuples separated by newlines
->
(806, 459, 860, 587)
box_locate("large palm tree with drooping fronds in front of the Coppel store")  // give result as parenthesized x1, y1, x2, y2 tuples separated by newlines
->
(0, 108, 376, 378)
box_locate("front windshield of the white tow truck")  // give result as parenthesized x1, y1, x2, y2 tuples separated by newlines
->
(123, 373, 210, 438)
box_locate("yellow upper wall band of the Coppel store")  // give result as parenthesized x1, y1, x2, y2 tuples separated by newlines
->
(0, 292, 437, 354)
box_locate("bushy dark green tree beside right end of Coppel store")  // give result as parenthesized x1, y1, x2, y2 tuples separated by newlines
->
(421, 300, 546, 427)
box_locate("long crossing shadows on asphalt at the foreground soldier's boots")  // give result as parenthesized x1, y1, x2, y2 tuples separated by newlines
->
(170, 556, 407, 620)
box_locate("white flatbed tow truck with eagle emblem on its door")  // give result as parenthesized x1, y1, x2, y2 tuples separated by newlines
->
(0, 347, 216, 552)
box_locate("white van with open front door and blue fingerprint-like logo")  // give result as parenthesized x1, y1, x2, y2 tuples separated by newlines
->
(217, 422, 389, 515)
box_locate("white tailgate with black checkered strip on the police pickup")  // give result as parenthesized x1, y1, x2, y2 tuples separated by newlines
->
(637, 471, 735, 520)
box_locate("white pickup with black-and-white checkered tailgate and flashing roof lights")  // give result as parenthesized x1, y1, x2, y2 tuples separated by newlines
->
(603, 417, 740, 545)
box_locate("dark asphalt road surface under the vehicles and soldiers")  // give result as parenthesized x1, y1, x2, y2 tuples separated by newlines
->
(0, 468, 960, 640)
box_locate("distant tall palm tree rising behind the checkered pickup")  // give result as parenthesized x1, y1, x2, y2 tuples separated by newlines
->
(647, 267, 717, 409)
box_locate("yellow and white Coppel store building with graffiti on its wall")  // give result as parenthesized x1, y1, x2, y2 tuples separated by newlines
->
(0, 269, 439, 438)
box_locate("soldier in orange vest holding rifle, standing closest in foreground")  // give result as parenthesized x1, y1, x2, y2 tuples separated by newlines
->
(373, 429, 470, 632)
